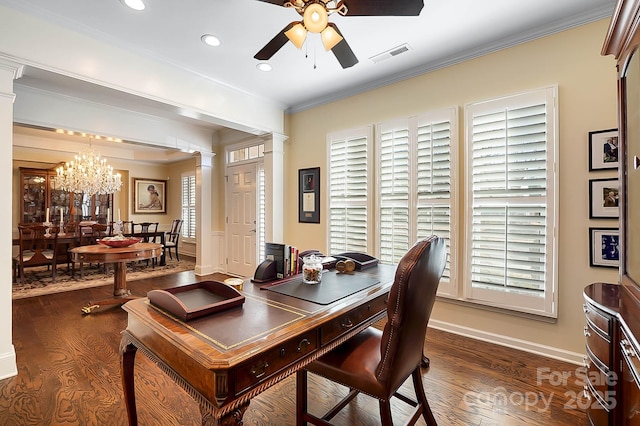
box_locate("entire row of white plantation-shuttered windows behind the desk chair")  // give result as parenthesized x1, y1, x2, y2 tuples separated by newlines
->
(328, 87, 557, 317)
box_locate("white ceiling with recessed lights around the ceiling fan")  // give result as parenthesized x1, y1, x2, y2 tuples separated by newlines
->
(0, 0, 615, 120)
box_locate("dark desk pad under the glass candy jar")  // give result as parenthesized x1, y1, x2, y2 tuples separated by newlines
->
(267, 271, 380, 305)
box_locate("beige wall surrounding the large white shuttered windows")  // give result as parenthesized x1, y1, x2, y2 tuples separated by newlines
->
(285, 20, 617, 355)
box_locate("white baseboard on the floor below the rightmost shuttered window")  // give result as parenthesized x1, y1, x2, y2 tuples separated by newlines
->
(429, 319, 584, 365)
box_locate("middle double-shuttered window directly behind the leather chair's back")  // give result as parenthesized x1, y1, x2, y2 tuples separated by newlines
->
(376, 108, 457, 295)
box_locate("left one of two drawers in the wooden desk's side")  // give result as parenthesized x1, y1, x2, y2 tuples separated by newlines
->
(235, 330, 318, 395)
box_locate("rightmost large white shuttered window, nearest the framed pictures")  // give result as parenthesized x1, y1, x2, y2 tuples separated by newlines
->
(465, 87, 557, 317)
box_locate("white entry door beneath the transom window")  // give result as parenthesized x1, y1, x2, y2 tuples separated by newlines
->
(226, 164, 257, 277)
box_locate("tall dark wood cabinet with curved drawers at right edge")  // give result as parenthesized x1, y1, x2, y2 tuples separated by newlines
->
(585, 0, 640, 426)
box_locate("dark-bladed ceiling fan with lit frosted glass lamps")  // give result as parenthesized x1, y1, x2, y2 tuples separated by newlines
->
(254, 0, 424, 68)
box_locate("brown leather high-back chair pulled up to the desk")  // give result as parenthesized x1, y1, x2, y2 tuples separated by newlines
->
(296, 235, 447, 426)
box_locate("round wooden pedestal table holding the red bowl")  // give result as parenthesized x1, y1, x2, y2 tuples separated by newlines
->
(69, 243, 162, 314)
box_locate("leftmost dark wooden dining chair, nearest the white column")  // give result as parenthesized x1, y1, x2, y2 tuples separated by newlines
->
(13, 225, 58, 283)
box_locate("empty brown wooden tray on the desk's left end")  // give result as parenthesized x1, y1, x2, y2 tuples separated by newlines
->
(147, 281, 245, 321)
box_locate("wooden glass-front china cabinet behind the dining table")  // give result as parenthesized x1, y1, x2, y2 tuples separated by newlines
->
(20, 168, 113, 224)
